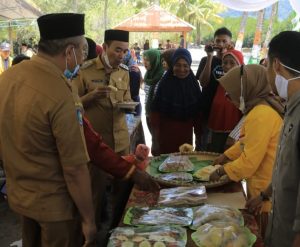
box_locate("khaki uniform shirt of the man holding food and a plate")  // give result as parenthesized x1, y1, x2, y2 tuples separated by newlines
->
(75, 57, 131, 152)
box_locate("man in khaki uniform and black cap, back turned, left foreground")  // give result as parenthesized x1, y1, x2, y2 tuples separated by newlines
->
(0, 13, 96, 247)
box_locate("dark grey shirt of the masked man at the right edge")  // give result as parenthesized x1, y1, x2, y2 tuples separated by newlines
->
(266, 92, 300, 247)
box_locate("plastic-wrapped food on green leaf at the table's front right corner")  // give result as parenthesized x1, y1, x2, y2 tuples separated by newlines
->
(192, 221, 256, 247)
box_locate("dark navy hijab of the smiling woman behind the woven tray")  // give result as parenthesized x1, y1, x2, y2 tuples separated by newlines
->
(152, 48, 201, 121)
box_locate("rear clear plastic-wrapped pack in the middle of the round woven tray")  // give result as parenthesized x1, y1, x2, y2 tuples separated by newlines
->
(158, 155, 194, 172)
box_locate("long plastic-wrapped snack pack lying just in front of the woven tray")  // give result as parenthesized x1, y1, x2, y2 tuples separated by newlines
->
(158, 185, 207, 206)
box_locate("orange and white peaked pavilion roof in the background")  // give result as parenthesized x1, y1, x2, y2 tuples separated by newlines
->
(113, 5, 195, 33)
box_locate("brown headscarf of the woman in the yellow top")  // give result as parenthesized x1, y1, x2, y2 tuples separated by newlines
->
(219, 64, 284, 116)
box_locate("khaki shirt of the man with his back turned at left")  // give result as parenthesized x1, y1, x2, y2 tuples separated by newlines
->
(0, 56, 89, 221)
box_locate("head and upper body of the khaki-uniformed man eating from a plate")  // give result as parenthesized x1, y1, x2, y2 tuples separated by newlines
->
(75, 30, 131, 155)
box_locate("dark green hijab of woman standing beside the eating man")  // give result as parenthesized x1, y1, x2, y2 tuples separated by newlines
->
(144, 49, 164, 86)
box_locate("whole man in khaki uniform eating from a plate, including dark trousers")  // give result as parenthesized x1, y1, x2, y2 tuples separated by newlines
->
(75, 30, 131, 239)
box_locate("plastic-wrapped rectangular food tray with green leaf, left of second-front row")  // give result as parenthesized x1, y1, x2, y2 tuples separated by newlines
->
(124, 207, 193, 226)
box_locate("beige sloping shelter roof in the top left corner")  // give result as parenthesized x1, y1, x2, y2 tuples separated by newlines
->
(0, 0, 42, 20)
